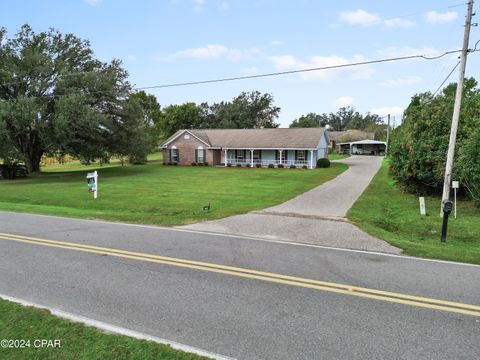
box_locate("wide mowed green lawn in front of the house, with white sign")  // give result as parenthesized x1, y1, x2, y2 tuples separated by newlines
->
(0, 161, 347, 225)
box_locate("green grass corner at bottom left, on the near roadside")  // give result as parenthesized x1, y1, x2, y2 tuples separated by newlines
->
(0, 299, 206, 360)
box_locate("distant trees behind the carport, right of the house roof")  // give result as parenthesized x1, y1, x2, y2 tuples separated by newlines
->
(290, 106, 387, 140)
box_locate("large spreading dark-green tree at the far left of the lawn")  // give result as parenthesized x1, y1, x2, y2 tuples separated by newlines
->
(0, 25, 130, 172)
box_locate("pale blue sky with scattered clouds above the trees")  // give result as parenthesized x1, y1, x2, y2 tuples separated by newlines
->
(0, 0, 480, 127)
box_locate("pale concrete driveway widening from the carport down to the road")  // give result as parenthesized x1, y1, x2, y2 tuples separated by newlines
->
(181, 156, 401, 254)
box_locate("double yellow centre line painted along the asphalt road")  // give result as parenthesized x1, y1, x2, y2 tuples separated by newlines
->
(0, 233, 480, 317)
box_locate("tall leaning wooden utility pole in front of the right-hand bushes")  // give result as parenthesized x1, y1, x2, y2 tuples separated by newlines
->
(440, 0, 473, 217)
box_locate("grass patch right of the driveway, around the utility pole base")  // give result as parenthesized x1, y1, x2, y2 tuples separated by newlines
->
(347, 160, 480, 264)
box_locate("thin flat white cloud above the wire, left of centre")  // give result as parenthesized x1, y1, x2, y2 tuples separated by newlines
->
(157, 44, 260, 62)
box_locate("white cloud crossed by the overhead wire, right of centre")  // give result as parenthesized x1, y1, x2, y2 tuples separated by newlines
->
(269, 55, 375, 80)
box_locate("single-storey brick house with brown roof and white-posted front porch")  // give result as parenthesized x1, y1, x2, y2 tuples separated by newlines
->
(162, 128, 329, 169)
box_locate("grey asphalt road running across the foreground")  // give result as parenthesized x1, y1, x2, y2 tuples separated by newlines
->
(0, 212, 480, 359)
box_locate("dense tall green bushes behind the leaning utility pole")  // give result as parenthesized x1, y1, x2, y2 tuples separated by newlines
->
(389, 78, 480, 206)
